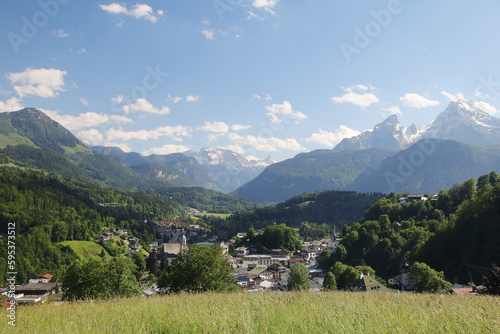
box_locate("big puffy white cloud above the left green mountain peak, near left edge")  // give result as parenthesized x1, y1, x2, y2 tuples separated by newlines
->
(7, 68, 68, 98)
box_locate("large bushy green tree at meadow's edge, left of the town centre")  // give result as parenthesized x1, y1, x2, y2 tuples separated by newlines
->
(159, 245, 237, 292)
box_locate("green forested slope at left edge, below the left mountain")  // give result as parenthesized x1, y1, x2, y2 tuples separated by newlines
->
(0, 167, 181, 283)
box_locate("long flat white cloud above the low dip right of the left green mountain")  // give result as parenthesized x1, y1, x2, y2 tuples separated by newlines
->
(106, 125, 190, 141)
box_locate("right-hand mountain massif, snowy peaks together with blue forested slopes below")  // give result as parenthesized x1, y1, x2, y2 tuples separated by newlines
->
(235, 101, 500, 203)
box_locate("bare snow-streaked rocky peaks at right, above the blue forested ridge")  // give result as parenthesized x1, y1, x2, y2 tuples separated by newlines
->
(334, 100, 500, 151)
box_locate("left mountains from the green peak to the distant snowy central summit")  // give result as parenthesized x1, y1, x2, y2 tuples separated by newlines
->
(0, 108, 273, 192)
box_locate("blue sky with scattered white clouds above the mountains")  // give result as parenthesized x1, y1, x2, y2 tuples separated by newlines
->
(0, 0, 500, 160)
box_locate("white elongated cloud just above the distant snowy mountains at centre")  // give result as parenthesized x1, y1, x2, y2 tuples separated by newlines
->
(228, 133, 305, 152)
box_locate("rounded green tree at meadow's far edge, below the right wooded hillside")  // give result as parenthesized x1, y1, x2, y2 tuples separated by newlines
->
(408, 262, 451, 292)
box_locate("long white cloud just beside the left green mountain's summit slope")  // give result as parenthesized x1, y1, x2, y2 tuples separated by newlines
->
(42, 109, 133, 130)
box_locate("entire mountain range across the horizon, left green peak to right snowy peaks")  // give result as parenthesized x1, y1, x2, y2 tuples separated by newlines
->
(0, 101, 500, 203)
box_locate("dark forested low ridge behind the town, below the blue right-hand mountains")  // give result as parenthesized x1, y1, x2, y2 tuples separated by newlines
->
(205, 191, 384, 240)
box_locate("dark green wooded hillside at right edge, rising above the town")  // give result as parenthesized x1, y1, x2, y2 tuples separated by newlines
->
(322, 172, 500, 282)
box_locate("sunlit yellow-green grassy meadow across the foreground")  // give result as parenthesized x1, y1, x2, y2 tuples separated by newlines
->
(4, 292, 500, 334)
